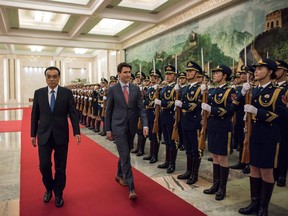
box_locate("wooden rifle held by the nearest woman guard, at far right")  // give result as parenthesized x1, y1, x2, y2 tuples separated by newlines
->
(241, 70, 252, 163)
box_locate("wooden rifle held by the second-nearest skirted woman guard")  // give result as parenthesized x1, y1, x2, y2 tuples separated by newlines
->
(198, 76, 208, 150)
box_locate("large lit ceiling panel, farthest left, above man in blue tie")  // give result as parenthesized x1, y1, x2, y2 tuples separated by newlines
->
(19, 9, 70, 31)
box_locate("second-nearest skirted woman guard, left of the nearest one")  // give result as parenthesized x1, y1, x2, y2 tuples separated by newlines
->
(201, 65, 235, 200)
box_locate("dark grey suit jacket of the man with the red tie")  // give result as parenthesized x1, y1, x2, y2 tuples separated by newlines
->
(106, 83, 148, 135)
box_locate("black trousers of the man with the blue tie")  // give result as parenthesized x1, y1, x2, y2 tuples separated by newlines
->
(38, 133, 68, 196)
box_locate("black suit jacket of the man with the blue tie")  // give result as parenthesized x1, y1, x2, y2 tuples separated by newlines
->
(31, 86, 80, 145)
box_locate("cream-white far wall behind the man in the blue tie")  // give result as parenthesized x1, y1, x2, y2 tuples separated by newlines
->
(0, 51, 121, 105)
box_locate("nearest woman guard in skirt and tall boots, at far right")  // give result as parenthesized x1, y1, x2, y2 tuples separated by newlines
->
(236, 58, 285, 216)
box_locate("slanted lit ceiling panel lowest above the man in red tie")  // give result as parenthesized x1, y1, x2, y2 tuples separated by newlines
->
(89, 18, 133, 36)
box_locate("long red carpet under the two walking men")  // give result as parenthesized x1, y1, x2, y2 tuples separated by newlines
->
(20, 109, 205, 216)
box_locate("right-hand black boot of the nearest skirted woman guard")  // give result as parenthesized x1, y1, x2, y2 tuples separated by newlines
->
(258, 181, 274, 216)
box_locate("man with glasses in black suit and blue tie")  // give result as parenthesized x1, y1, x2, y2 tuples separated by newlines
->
(31, 66, 80, 207)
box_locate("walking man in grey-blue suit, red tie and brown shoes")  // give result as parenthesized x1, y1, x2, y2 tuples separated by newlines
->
(106, 62, 148, 200)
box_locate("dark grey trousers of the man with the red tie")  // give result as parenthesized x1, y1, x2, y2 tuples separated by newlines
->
(114, 129, 134, 191)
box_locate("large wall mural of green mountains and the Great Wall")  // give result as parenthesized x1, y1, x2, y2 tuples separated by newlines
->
(126, 0, 288, 77)
